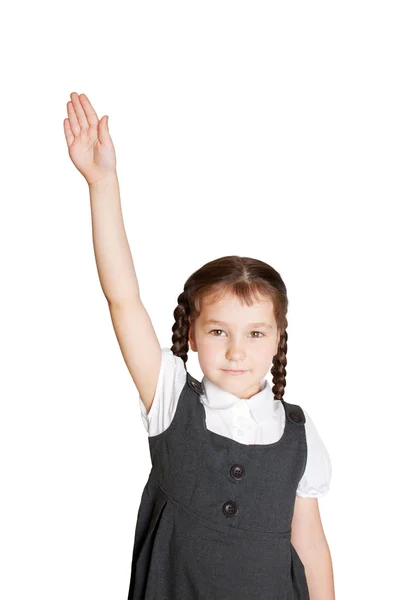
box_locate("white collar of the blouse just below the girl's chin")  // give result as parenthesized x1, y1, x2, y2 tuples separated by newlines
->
(201, 376, 281, 423)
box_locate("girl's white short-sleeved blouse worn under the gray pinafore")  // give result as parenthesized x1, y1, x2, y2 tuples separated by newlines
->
(139, 348, 332, 498)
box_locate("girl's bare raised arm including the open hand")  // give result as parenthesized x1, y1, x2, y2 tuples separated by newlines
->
(64, 92, 161, 411)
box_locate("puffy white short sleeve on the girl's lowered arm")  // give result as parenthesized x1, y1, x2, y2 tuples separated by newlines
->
(296, 409, 332, 498)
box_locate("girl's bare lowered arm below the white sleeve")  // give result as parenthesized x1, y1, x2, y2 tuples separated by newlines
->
(291, 496, 335, 600)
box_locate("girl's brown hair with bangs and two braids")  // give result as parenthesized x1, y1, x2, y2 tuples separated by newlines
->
(171, 256, 288, 400)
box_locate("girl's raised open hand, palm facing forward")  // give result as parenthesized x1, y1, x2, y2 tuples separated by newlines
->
(64, 92, 117, 185)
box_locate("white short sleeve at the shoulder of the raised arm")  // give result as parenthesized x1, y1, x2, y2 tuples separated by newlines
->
(139, 348, 186, 436)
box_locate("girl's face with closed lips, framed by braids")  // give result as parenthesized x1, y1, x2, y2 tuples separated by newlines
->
(189, 293, 279, 399)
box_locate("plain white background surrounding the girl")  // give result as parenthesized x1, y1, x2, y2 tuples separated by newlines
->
(0, 0, 400, 600)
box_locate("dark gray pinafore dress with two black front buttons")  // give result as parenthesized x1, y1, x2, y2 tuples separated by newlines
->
(128, 373, 309, 600)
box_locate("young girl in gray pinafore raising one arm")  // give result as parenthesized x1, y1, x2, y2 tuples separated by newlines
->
(64, 93, 334, 600)
